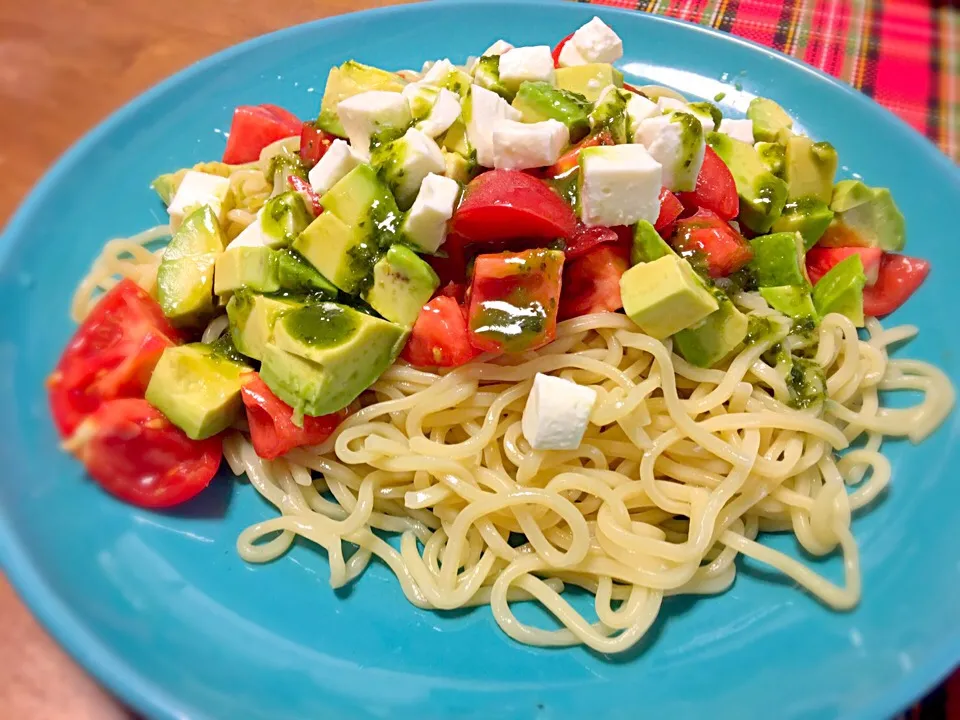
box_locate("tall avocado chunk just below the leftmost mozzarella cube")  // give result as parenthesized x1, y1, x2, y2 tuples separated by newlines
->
(157, 205, 226, 327)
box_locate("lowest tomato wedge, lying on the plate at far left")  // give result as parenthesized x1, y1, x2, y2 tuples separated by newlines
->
(68, 398, 222, 508)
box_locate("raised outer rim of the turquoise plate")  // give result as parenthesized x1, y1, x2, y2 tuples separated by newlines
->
(0, 0, 960, 720)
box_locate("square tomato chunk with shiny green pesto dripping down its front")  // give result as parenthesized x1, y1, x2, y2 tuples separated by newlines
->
(467, 248, 564, 352)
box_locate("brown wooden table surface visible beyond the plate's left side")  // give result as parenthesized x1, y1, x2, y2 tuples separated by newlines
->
(0, 0, 404, 720)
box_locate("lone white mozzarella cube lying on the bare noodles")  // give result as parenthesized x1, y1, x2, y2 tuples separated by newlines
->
(520, 373, 597, 450)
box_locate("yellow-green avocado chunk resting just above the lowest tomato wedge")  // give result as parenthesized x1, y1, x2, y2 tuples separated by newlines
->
(145, 343, 250, 440)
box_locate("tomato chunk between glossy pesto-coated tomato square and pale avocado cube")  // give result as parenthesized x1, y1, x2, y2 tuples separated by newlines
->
(559, 245, 630, 320)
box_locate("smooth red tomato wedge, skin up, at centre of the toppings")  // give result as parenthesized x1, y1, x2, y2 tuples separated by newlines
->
(452, 170, 577, 243)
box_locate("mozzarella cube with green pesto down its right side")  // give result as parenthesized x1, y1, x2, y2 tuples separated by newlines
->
(639, 112, 706, 192)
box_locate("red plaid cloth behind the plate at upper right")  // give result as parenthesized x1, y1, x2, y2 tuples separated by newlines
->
(580, 0, 960, 162)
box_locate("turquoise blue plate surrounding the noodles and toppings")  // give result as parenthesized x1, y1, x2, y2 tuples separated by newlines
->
(0, 0, 960, 720)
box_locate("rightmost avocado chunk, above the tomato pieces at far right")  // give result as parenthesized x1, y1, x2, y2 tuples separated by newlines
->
(830, 180, 907, 252)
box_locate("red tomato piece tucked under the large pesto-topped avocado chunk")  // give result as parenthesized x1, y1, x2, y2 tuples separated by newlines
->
(240, 373, 347, 460)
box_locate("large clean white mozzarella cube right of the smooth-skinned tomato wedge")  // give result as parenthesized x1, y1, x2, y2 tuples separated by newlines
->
(579, 145, 663, 227)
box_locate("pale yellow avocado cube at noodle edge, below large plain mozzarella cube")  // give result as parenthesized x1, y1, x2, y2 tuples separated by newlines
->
(620, 255, 719, 340)
